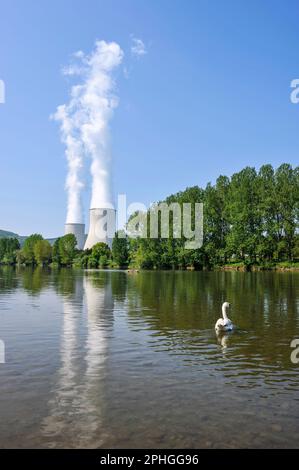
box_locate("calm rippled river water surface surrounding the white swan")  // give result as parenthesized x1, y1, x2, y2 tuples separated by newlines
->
(0, 268, 299, 448)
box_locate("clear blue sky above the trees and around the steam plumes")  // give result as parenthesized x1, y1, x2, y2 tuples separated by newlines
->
(0, 0, 299, 236)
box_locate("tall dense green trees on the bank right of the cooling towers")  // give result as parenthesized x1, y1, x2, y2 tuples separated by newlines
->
(130, 164, 299, 268)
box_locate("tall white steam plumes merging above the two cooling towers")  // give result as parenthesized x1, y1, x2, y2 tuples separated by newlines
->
(53, 41, 124, 223)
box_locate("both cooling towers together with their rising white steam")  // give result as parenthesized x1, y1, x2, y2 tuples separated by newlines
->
(53, 41, 124, 250)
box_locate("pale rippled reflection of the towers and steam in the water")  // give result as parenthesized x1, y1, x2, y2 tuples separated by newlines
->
(43, 278, 113, 448)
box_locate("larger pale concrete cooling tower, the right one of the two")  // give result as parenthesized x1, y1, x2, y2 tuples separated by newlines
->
(84, 208, 116, 250)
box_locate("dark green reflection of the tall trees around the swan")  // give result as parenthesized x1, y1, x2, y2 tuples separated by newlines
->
(128, 272, 299, 380)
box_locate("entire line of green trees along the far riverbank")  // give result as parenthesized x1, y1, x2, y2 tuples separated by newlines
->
(0, 163, 299, 269)
